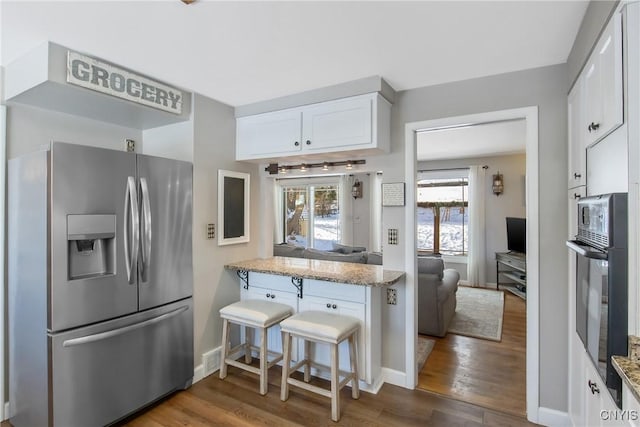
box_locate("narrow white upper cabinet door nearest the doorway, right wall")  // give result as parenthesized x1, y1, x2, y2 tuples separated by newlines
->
(567, 77, 587, 188)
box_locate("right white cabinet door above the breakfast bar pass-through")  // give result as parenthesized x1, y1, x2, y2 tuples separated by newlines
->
(302, 97, 374, 151)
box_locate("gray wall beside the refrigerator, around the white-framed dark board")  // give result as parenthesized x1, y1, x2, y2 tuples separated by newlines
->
(193, 94, 260, 366)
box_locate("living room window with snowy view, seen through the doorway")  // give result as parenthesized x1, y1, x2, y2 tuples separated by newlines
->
(417, 169, 469, 255)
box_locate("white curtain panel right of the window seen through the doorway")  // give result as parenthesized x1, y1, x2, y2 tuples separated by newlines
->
(467, 166, 486, 286)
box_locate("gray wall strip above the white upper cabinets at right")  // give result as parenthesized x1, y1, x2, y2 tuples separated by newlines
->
(567, 0, 620, 86)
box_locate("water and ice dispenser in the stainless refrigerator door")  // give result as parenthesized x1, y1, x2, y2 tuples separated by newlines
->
(67, 215, 116, 280)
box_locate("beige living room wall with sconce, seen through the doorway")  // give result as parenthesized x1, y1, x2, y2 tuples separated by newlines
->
(418, 153, 526, 287)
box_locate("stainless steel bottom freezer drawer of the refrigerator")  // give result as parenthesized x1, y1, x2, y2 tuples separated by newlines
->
(49, 298, 193, 427)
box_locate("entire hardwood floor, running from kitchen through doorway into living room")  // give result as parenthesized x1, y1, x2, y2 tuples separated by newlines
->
(0, 294, 534, 427)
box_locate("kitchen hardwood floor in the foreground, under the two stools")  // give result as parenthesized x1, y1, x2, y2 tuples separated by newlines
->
(119, 366, 533, 427)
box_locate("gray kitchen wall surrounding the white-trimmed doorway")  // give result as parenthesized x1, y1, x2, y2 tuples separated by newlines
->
(367, 64, 568, 411)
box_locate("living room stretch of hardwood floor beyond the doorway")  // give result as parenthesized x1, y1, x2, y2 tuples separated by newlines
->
(418, 292, 527, 416)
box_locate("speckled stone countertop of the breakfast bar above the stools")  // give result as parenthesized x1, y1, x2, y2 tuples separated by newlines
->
(224, 256, 405, 287)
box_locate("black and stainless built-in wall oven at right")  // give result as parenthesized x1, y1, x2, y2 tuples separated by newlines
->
(567, 193, 628, 407)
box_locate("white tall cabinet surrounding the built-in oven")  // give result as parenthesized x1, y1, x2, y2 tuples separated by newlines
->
(567, 4, 631, 426)
